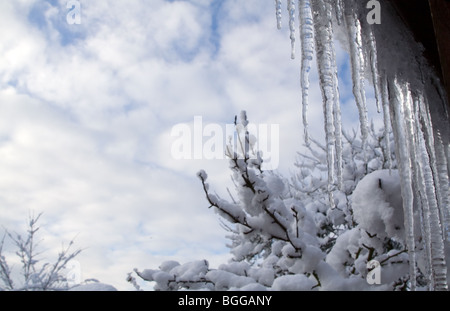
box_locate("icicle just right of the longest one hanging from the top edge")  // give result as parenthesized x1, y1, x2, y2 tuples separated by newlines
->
(345, 12, 369, 146)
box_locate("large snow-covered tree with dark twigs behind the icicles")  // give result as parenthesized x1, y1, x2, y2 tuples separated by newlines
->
(128, 112, 422, 290)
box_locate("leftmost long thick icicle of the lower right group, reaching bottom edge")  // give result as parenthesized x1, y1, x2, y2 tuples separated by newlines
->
(389, 80, 417, 291)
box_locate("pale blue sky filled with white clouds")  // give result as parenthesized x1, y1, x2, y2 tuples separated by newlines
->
(0, 0, 375, 290)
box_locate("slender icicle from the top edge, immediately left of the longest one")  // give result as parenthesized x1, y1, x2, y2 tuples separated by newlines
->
(298, 0, 314, 145)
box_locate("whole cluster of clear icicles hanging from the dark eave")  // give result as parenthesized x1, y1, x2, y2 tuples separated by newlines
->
(275, 0, 450, 290)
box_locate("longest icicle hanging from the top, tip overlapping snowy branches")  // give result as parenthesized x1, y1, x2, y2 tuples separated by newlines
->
(312, 0, 338, 207)
